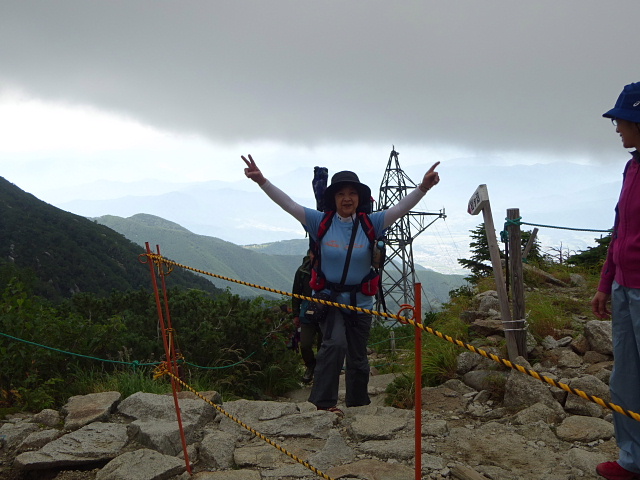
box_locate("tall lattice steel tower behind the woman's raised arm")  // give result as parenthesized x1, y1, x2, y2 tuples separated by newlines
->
(376, 146, 446, 313)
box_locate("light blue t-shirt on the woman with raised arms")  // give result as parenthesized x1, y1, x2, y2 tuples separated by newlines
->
(304, 208, 386, 309)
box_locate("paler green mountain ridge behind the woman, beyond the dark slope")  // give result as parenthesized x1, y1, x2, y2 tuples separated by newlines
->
(95, 214, 465, 309)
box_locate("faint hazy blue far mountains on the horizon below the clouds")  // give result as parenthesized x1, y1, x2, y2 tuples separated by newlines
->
(47, 158, 621, 275)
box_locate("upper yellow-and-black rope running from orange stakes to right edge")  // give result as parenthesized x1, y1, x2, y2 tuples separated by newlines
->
(140, 254, 640, 421)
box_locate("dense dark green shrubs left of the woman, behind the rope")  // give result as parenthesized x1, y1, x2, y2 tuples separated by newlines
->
(0, 280, 301, 410)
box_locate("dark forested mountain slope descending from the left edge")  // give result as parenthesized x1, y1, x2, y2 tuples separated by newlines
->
(0, 177, 220, 301)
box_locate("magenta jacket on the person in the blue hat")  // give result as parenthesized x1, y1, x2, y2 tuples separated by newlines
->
(598, 151, 640, 294)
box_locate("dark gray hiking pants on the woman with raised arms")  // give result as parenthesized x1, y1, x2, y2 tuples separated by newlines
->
(309, 307, 371, 408)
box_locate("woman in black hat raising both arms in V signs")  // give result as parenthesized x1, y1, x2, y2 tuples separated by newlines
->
(242, 155, 440, 415)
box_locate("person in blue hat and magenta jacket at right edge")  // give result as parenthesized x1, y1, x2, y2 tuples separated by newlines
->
(591, 82, 640, 480)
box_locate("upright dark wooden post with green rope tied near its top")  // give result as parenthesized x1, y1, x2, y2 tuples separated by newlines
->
(507, 208, 527, 358)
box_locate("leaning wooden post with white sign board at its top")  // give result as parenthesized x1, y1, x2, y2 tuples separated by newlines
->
(467, 184, 518, 361)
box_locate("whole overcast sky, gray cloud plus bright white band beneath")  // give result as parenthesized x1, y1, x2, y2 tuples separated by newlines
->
(0, 0, 640, 270)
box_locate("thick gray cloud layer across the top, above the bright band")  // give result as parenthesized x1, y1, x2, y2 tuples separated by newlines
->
(0, 0, 640, 158)
